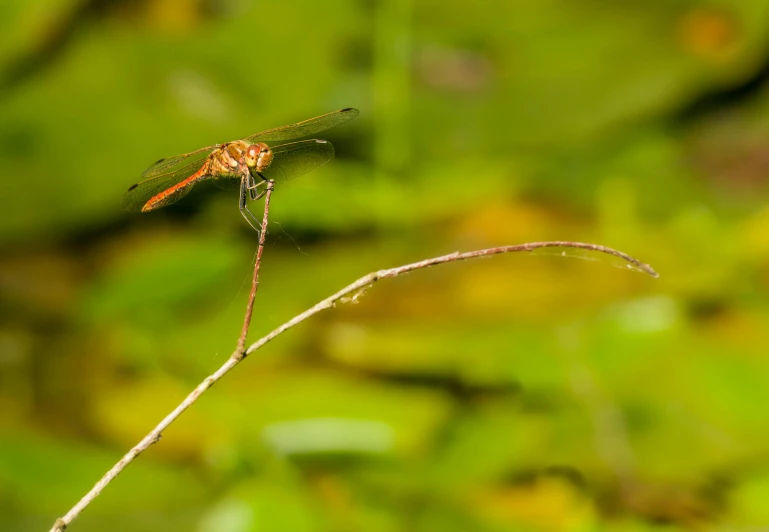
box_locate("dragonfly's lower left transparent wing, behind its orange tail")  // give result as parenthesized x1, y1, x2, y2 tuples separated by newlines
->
(121, 157, 207, 211)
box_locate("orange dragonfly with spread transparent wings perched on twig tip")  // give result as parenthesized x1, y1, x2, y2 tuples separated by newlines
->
(122, 107, 358, 231)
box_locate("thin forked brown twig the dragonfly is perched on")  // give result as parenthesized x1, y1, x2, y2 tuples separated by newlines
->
(51, 242, 657, 532)
